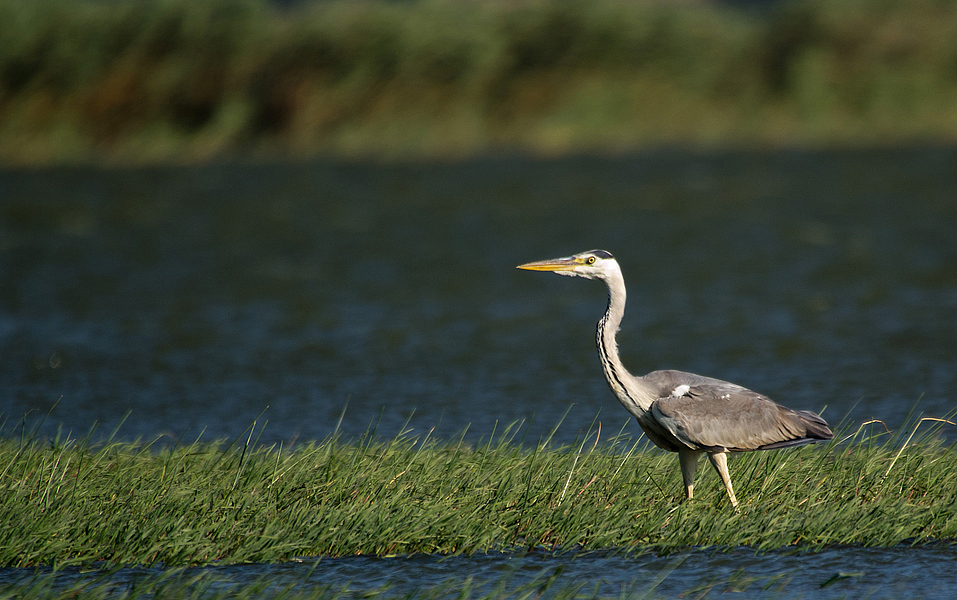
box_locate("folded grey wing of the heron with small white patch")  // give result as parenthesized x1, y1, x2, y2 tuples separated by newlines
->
(651, 371, 832, 452)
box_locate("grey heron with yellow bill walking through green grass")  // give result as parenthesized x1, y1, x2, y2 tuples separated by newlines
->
(518, 250, 834, 507)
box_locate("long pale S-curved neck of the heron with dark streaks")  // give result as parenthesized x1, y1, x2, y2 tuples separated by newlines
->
(596, 278, 654, 418)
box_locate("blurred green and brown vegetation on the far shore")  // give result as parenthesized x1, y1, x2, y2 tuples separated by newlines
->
(0, 0, 957, 165)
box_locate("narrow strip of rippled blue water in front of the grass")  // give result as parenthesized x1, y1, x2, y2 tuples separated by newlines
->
(0, 545, 957, 600)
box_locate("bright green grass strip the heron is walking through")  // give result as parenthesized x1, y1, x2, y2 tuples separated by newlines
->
(0, 414, 957, 567)
